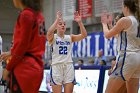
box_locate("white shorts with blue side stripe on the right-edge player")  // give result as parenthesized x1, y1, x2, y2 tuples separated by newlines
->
(111, 52, 140, 81)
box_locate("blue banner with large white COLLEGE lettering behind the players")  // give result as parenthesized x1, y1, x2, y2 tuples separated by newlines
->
(72, 32, 117, 58)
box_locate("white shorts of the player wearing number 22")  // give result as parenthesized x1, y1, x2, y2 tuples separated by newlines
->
(50, 63, 76, 85)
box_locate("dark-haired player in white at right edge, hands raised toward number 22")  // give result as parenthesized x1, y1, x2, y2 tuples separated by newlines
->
(102, 0, 140, 93)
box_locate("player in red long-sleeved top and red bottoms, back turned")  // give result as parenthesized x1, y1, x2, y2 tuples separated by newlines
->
(0, 0, 46, 93)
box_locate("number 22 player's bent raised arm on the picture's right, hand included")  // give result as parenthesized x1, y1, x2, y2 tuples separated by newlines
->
(71, 11, 87, 42)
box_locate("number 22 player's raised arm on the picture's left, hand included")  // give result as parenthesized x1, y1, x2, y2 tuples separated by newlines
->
(47, 11, 62, 43)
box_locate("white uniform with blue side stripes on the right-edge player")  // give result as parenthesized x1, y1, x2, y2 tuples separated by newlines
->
(111, 16, 140, 80)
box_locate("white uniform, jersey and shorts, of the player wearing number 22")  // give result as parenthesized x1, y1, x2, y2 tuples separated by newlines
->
(50, 34, 75, 85)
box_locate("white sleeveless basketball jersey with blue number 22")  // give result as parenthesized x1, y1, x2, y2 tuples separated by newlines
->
(52, 34, 73, 65)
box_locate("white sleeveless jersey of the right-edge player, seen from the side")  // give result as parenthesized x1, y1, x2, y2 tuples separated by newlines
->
(118, 16, 140, 52)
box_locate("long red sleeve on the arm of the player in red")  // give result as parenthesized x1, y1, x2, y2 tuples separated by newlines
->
(6, 12, 34, 71)
